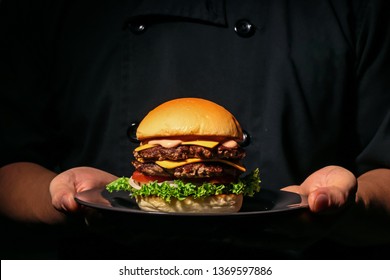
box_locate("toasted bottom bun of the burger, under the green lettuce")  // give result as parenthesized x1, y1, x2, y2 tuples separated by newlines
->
(136, 194, 243, 213)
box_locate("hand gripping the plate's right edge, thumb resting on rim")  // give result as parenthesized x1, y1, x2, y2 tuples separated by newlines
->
(282, 166, 357, 213)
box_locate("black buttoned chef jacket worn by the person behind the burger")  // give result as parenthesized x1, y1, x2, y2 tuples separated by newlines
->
(0, 0, 390, 258)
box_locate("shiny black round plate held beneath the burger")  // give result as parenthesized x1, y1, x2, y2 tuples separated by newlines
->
(75, 188, 308, 216)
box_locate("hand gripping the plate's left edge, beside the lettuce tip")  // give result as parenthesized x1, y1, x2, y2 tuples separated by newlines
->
(50, 167, 117, 212)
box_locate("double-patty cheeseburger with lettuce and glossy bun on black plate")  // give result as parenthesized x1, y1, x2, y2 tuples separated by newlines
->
(107, 98, 260, 213)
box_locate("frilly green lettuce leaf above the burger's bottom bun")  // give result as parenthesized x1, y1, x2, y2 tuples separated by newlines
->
(106, 168, 261, 202)
